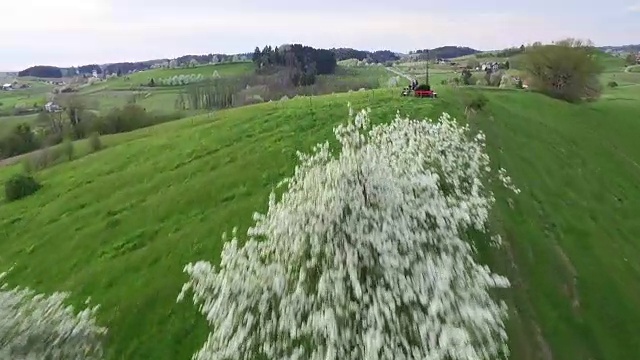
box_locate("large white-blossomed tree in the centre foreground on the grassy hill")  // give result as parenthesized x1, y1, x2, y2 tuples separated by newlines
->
(178, 105, 517, 360)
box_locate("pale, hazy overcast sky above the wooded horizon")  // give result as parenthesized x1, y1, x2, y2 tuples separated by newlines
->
(0, 0, 640, 71)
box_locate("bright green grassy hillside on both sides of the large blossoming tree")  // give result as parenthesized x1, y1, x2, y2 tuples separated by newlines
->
(0, 82, 640, 360)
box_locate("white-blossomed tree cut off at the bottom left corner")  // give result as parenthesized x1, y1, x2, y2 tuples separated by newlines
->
(0, 273, 107, 360)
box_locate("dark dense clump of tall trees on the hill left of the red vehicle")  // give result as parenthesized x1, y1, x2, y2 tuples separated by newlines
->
(251, 44, 337, 86)
